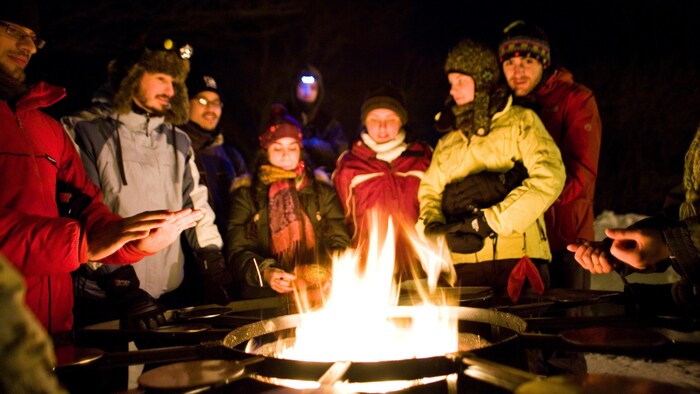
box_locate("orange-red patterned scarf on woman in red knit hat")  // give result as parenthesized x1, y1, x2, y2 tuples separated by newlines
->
(260, 162, 316, 272)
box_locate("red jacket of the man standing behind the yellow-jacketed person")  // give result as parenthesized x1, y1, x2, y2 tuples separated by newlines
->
(536, 68, 602, 251)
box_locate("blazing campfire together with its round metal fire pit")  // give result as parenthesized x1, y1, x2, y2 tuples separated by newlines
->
(220, 214, 524, 392)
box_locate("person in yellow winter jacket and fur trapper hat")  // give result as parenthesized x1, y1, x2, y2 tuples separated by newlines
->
(417, 39, 565, 299)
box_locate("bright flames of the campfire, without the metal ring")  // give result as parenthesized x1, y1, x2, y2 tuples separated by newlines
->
(276, 216, 458, 362)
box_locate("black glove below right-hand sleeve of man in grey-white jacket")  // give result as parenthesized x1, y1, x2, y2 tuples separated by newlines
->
(196, 249, 233, 305)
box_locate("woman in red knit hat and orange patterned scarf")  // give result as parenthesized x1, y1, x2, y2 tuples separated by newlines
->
(226, 105, 350, 298)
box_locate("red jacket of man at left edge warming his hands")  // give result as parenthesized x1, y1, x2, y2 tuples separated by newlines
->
(0, 82, 149, 333)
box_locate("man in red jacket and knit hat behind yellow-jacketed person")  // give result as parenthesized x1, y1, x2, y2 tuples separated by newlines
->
(498, 21, 602, 289)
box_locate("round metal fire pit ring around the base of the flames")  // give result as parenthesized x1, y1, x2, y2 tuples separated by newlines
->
(219, 307, 526, 392)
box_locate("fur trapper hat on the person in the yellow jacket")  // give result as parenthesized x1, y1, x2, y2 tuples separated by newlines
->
(445, 39, 502, 136)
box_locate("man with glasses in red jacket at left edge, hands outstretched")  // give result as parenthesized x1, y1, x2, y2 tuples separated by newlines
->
(0, 0, 202, 334)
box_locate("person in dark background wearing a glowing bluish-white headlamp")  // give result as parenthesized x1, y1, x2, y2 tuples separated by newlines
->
(287, 65, 348, 174)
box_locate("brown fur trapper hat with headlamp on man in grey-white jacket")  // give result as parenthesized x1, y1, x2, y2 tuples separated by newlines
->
(114, 40, 192, 124)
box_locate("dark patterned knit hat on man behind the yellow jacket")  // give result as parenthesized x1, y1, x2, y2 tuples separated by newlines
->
(498, 21, 552, 68)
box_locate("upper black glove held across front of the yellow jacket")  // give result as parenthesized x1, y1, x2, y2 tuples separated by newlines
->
(442, 161, 528, 216)
